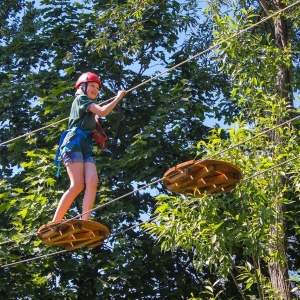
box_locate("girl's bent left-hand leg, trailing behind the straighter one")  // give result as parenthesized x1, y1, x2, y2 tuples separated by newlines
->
(53, 162, 84, 222)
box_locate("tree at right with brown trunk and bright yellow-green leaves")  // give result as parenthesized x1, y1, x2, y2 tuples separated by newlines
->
(150, 1, 299, 299)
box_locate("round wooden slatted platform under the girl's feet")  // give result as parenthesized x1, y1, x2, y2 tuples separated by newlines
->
(38, 219, 109, 250)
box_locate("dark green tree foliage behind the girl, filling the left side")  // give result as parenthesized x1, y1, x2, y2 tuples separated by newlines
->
(0, 0, 226, 299)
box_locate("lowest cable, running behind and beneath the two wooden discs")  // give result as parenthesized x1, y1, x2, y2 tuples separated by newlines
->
(0, 155, 300, 269)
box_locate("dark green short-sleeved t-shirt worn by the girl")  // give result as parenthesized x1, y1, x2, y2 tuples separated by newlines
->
(61, 90, 97, 152)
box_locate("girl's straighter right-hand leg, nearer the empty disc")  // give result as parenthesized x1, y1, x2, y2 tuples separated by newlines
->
(82, 162, 98, 220)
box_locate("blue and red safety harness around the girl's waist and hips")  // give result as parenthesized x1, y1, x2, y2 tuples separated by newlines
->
(54, 115, 107, 177)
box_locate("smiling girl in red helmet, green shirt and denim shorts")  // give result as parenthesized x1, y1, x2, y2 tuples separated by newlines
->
(53, 72, 126, 222)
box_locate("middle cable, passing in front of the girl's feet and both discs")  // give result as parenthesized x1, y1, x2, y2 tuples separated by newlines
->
(0, 115, 300, 246)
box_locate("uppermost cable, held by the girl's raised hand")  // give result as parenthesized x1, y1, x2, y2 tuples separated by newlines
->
(0, 0, 300, 146)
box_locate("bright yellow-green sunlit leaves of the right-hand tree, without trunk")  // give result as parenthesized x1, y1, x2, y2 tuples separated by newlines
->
(147, 2, 299, 297)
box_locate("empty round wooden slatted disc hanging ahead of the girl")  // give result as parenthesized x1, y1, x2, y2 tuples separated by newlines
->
(162, 160, 242, 195)
